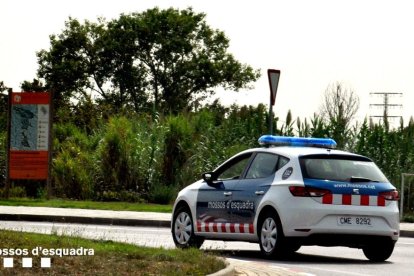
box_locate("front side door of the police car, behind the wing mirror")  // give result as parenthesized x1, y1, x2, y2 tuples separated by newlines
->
(196, 153, 252, 233)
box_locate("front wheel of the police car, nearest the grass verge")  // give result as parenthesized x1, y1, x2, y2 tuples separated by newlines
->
(171, 207, 204, 248)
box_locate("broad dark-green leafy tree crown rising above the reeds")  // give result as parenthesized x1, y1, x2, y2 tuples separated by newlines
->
(38, 8, 260, 113)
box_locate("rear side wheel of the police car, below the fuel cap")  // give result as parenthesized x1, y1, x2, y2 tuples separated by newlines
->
(258, 212, 285, 258)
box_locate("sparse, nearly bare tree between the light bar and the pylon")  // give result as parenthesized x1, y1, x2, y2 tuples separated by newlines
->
(321, 82, 359, 148)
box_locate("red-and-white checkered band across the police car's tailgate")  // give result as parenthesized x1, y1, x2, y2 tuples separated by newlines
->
(315, 194, 385, 206)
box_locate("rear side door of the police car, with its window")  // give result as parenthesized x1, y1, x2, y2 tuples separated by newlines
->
(230, 152, 279, 234)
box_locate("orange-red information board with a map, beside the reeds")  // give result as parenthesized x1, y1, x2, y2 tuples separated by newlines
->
(9, 92, 50, 180)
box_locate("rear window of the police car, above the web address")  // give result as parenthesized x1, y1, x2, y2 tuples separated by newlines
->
(299, 155, 389, 182)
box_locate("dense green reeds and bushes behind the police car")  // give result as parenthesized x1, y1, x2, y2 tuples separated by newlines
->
(0, 103, 414, 212)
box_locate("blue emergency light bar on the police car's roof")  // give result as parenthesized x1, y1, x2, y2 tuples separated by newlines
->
(258, 135, 336, 149)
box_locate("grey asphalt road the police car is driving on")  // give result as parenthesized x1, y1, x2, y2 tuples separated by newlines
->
(0, 221, 414, 276)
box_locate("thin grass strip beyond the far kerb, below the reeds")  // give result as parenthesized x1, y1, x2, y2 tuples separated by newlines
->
(0, 198, 172, 213)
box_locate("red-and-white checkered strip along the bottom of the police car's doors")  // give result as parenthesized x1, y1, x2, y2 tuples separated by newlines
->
(197, 220, 254, 234)
